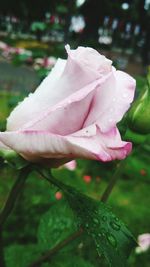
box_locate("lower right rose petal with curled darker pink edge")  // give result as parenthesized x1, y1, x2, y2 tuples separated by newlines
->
(67, 125, 132, 162)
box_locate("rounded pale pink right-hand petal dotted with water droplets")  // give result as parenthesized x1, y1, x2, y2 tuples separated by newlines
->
(84, 69, 135, 132)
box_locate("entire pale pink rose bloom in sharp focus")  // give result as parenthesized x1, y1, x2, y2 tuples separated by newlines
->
(0, 45, 135, 166)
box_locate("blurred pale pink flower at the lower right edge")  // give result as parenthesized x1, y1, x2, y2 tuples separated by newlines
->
(135, 233, 150, 253)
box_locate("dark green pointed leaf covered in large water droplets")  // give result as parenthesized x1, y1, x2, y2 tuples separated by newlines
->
(63, 187, 136, 267)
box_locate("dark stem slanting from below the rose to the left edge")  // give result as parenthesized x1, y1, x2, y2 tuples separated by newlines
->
(0, 167, 30, 229)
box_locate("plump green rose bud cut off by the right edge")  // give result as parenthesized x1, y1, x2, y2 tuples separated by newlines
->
(128, 82, 150, 135)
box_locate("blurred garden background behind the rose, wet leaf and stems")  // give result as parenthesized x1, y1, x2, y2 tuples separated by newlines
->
(0, 0, 150, 267)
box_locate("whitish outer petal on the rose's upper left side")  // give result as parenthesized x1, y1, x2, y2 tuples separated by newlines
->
(7, 59, 66, 131)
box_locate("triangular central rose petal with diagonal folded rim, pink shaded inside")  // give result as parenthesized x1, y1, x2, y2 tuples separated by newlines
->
(18, 74, 111, 135)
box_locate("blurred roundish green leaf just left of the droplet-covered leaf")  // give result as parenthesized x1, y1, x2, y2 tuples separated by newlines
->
(38, 201, 77, 249)
